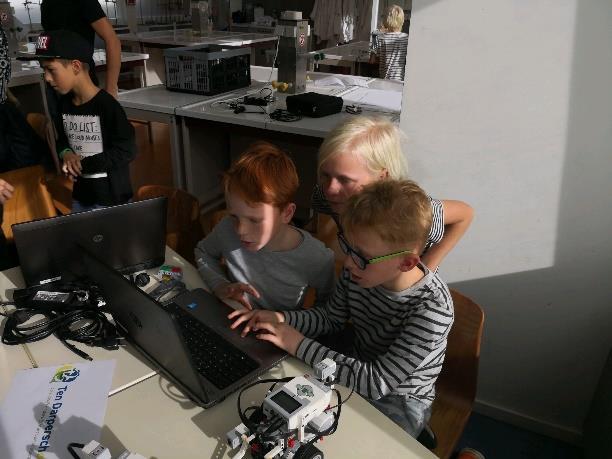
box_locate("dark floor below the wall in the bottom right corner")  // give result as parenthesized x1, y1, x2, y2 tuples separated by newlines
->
(458, 413, 582, 459)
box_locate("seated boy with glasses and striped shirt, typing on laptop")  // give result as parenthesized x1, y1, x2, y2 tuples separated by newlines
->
(229, 180, 453, 438)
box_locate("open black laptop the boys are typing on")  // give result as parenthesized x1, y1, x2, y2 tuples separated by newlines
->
(81, 249, 287, 408)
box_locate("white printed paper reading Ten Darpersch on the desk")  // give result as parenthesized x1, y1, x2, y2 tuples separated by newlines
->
(0, 360, 115, 459)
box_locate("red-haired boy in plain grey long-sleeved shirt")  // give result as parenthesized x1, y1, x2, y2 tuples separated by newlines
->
(195, 142, 334, 311)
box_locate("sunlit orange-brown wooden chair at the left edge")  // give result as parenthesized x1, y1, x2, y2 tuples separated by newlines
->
(0, 166, 57, 241)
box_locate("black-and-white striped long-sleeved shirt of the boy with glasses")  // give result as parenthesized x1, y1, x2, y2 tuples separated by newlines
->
(284, 265, 453, 404)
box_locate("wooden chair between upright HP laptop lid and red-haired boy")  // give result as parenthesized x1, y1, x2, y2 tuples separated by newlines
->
(134, 185, 204, 263)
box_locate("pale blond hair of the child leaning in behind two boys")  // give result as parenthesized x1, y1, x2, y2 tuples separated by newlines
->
(319, 116, 408, 180)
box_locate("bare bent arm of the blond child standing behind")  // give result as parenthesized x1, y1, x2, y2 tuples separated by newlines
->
(421, 200, 474, 271)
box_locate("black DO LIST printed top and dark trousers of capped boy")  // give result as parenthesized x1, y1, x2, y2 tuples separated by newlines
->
(57, 89, 136, 206)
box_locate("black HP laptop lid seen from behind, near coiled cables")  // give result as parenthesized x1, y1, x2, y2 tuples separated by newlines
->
(12, 197, 167, 286)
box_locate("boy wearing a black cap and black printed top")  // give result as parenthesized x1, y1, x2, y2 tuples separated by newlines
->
(21, 30, 136, 212)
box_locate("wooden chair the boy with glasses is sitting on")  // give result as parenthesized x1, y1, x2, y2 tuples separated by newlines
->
(429, 290, 484, 459)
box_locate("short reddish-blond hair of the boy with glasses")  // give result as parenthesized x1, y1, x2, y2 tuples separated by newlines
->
(341, 180, 432, 253)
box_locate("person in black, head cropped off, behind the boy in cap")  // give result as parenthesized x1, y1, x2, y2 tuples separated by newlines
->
(40, 0, 121, 99)
